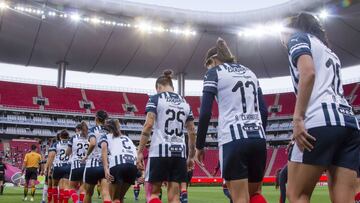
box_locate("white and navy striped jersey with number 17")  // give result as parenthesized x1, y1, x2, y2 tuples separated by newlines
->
(203, 63, 266, 145)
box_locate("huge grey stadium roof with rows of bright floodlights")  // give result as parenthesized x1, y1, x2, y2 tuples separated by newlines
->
(0, 0, 360, 79)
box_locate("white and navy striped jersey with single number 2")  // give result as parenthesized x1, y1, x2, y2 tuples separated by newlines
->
(99, 134, 137, 168)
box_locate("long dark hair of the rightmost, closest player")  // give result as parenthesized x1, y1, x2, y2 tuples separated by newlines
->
(288, 12, 329, 46)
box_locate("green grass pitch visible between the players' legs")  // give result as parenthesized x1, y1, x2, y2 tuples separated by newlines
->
(0, 186, 330, 203)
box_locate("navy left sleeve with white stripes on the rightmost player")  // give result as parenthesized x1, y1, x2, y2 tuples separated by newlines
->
(288, 33, 312, 66)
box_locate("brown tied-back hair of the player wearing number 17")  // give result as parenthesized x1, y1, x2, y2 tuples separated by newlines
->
(204, 37, 236, 67)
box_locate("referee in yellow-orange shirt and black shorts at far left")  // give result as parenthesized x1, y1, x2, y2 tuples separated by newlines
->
(22, 145, 42, 202)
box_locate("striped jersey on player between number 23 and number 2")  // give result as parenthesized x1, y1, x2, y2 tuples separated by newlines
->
(86, 125, 107, 167)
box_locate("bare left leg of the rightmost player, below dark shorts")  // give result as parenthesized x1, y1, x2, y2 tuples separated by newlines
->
(286, 161, 325, 203)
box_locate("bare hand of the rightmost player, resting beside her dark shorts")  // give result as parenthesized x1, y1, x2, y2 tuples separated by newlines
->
(293, 119, 316, 152)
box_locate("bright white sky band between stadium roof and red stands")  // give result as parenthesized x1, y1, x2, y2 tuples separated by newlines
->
(0, 63, 360, 95)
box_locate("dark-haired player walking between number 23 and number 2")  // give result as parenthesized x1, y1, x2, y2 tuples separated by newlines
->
(83, 110, 111, 203)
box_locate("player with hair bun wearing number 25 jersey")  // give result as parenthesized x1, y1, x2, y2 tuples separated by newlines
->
(137, 70, 195, 203)
